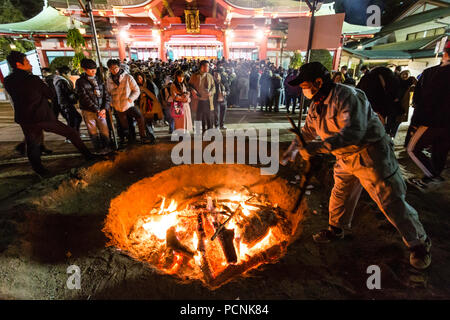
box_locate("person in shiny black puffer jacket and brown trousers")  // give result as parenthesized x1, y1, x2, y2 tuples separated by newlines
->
(75, 58, 111, 153)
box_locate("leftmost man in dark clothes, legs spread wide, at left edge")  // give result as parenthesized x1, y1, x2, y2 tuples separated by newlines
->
(4, 51, 94, 177)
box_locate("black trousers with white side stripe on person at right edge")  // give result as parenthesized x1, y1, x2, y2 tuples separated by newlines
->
(406, 126, 450, 178)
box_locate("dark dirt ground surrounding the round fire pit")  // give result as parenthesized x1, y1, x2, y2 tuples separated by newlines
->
(0, 132, 450, 300)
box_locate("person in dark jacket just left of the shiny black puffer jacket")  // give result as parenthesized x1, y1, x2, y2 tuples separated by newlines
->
(53, 66, 82, 133)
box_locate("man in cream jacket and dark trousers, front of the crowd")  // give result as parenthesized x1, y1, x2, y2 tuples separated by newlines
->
(106, 59, 149, 144)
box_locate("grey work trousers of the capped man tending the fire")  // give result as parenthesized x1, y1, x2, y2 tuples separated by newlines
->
(329, 136, 427, 247)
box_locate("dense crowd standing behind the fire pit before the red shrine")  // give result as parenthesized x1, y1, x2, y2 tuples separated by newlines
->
(36, 59, 301, 153)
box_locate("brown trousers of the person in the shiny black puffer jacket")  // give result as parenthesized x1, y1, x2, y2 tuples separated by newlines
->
(81, 110, 111, 152)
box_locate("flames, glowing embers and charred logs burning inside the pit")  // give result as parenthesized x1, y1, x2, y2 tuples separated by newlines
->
(129, 191, 291, 283)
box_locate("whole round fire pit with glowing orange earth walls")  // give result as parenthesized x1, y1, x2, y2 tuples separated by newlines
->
(103, 164, 304, 289)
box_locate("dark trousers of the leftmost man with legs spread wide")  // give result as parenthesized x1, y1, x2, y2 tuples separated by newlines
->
(20, 120, 91, 173)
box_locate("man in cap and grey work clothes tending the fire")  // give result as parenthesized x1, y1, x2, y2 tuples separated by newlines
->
(289, 62, 431, 269)
